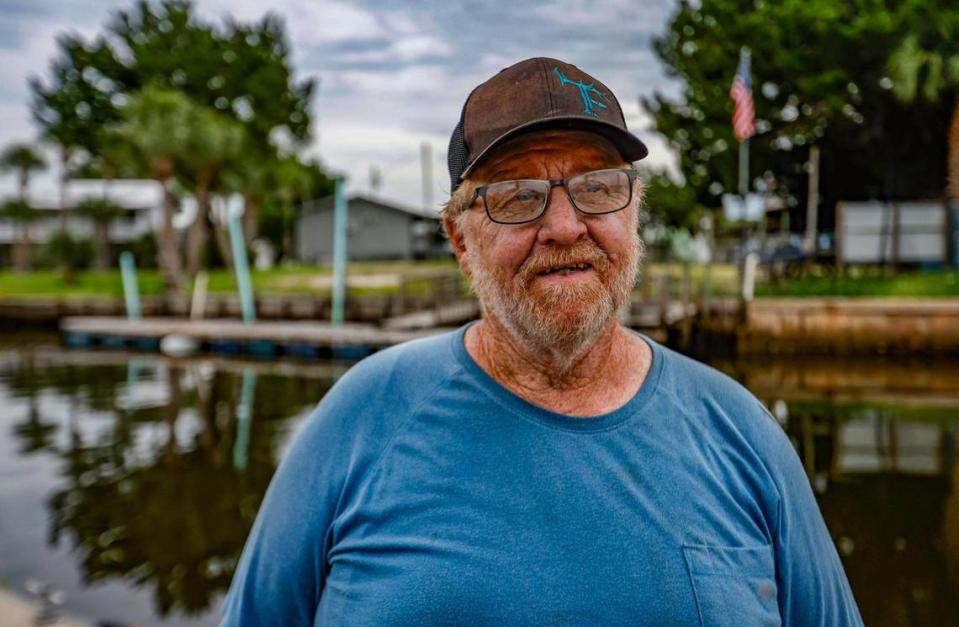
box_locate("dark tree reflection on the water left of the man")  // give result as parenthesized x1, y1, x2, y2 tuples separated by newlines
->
(0, 351, 332, 618)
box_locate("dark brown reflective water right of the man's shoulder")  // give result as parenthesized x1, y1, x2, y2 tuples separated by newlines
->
(719, 359, 959, 627)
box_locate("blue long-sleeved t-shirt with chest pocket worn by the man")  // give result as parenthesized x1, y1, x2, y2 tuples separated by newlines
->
(223, 327, 862, 627)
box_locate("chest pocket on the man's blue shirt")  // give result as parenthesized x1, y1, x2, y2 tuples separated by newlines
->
(683, 545, 782, 627)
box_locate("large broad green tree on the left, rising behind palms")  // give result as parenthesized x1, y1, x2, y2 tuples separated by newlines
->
(30, 0, 315, 278)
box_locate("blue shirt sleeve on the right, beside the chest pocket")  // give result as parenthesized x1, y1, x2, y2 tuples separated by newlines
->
(769, 410, 863, 627)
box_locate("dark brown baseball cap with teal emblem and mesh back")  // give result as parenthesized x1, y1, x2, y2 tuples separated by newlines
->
(447, 57, 648, 191)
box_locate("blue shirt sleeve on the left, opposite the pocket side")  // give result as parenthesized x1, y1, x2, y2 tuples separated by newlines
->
(221, 336, 449, 627)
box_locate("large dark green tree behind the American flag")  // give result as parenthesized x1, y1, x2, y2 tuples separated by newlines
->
(643, 0, 947, 233)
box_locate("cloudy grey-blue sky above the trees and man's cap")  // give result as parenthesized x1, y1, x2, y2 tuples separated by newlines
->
(0, 0, 676, 212)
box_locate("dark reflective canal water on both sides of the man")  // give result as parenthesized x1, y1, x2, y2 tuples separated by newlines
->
(0, 335, 959, 627)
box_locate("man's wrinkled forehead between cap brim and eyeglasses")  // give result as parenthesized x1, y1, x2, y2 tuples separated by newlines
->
(467, 130, 625, 182)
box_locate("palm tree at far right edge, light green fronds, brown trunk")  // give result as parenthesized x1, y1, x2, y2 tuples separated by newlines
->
(889, 33, 959, 206)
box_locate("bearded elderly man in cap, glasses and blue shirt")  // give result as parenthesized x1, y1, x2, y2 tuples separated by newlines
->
(224, 58, 861, 626)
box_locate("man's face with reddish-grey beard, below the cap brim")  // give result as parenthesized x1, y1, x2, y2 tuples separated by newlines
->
(453, 131, 642, 348)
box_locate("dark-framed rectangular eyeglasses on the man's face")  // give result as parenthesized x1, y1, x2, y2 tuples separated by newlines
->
(468, 168, 636, 224)
